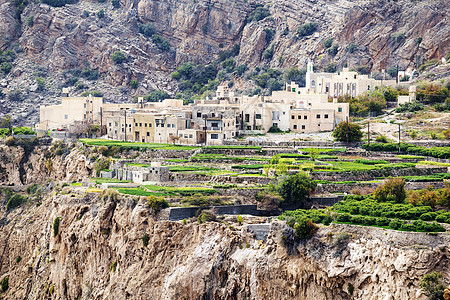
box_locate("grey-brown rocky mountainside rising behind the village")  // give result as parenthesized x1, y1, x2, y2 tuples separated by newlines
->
(0, 0, 450, 123)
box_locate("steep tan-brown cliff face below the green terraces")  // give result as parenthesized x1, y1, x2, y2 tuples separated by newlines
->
(0, 193, 450, 299)
